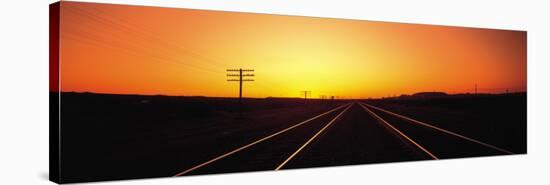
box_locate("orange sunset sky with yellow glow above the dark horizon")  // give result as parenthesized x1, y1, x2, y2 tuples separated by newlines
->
(60, 2, 527, 98)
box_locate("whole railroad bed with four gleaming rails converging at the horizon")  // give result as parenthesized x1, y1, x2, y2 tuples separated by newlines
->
(174, 102, 513, 176)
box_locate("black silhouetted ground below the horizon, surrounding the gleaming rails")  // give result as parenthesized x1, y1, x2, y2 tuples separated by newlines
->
(55, 92, 527, 182)
